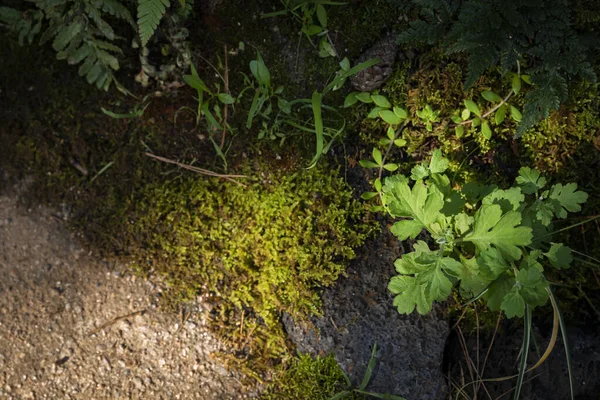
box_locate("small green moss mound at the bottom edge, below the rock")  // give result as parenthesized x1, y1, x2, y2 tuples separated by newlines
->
(263, 354, 347, 400)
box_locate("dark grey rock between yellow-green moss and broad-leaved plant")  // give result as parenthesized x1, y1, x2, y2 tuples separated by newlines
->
(284, 225, 449, 400)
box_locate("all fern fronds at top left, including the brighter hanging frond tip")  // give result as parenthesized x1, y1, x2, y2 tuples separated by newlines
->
(0, 0, 193, 92)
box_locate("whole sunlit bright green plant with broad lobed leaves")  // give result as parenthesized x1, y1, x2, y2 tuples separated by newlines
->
(364, 150, 587, 318)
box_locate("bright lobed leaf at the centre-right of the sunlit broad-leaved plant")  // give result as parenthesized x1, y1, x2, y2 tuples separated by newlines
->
(464, 204, 533, 261)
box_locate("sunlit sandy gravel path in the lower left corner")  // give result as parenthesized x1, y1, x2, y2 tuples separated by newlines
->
(0, 192, 256, 400)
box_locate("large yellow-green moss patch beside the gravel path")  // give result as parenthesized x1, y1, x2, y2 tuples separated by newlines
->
(126, 162, 371, 372)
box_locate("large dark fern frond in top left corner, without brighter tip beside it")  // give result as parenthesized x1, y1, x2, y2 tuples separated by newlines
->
(0, 0, 133, 90)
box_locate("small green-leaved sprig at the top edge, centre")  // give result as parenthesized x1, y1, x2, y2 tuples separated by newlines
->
(262, 0, 346, 58)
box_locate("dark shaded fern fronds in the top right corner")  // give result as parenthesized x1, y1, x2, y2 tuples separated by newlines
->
(400, 0, 596, 137)
